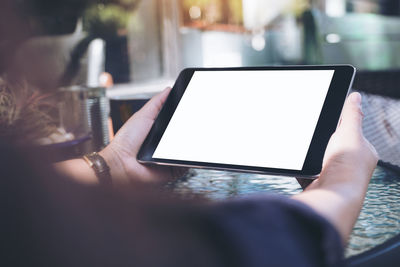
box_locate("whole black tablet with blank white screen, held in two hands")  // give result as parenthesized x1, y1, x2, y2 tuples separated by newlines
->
(138, 65, 355, 177)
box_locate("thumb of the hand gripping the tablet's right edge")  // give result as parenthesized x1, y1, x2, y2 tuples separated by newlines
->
(339, 92, 364, 131)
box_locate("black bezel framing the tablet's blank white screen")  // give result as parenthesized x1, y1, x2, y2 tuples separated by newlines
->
(137, 65, 355, 177)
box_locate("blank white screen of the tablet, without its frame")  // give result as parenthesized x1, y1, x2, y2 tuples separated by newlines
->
(153, 70, 334, 170)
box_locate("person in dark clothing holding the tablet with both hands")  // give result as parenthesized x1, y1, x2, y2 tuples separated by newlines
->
(0, 0, 377, 266)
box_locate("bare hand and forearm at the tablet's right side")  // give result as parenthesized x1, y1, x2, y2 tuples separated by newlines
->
(293, 93, 378, 243)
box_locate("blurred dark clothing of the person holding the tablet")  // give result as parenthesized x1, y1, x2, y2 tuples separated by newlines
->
(0, 148, 343, 267)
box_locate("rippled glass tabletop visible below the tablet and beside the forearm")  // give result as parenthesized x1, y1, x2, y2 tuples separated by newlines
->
(172, 166, 400, 257)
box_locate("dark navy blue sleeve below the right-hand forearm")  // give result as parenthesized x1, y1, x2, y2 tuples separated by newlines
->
(206, 195, 343, 267)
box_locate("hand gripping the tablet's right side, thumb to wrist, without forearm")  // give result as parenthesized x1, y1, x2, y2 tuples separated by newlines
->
(307, 93, 378, 193)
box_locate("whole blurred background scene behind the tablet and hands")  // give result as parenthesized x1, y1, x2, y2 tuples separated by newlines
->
(0, 0, 400, 157)
